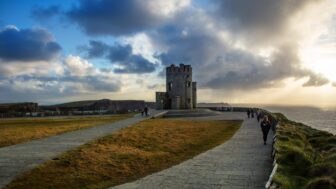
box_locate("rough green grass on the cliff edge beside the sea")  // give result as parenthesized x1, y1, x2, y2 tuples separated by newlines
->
(273, 114, 336, 189)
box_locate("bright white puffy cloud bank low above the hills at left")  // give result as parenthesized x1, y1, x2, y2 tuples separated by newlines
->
(0, 55, 122, 102)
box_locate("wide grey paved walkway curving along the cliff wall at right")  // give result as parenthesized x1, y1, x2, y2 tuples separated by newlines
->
(113, 112, 272, 189)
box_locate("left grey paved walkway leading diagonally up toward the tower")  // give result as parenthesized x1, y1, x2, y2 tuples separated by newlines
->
(0, 111, 160, 188)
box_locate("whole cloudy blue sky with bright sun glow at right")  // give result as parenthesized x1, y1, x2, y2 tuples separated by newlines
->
(0, 0, 336, 107)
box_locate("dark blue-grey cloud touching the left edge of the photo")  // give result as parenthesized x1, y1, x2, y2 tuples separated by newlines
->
(0, 27, 61, 61)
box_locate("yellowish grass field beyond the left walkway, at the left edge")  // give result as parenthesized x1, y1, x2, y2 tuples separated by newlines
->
(0, 114, 133, 147)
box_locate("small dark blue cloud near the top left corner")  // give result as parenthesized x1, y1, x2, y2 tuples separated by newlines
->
(31, 5, 61, 21)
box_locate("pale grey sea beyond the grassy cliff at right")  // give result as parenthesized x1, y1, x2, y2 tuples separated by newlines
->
(261, 105, 336, 135)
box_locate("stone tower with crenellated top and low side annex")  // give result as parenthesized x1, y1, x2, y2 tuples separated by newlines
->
(156, 64, 197, 109)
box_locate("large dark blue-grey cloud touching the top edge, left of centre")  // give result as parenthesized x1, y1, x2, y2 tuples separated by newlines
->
(66, 0, 160, 35)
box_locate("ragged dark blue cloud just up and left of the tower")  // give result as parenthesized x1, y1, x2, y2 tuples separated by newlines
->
(81, 41, 155, 73)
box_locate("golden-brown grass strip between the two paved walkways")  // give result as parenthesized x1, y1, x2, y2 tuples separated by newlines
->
(6, 119, 242, 189)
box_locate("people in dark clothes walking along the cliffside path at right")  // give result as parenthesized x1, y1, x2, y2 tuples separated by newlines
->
(247, 108, 277, 145)
